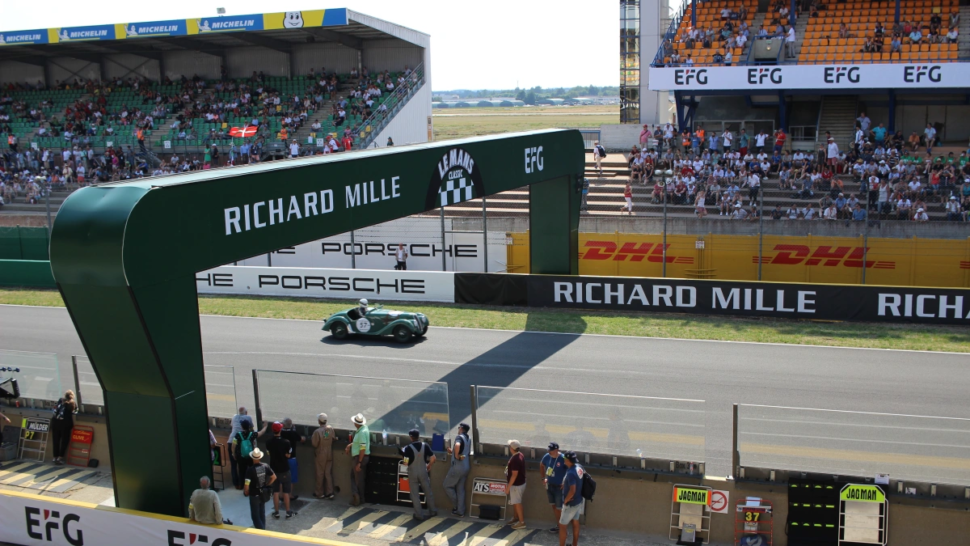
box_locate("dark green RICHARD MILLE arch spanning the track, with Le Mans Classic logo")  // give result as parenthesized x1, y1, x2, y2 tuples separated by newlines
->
(50, 130, 584, 515)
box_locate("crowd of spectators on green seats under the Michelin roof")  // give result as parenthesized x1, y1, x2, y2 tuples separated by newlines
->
(0, 67, 418, 206)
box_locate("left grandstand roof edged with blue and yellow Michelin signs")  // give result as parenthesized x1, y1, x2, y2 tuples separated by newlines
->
(0, 8, 430, 65)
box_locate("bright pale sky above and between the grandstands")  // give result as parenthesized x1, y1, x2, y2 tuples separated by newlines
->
(0, 0, 619, 91)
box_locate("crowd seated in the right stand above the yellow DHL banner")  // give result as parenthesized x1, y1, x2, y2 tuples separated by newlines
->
(623, 119, 970, 223)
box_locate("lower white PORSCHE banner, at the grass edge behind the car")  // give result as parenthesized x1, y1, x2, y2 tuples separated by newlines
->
(195, 266, 455, 303)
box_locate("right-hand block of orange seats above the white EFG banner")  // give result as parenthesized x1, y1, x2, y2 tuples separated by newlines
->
(798, 0, 958, 64)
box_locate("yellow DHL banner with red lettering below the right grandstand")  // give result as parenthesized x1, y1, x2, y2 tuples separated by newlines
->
(507, 233, 970, 287)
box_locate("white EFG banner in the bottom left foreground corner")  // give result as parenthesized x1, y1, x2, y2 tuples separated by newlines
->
(0, 491, 332, 546)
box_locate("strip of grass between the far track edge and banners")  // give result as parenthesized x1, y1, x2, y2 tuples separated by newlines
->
(0, 289, 970, 353)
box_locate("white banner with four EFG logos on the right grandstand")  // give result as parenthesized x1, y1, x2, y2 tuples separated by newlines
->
(649, 63, 970, 91)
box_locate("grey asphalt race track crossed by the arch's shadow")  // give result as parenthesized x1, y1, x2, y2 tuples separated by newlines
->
(0, 305, 970, 485)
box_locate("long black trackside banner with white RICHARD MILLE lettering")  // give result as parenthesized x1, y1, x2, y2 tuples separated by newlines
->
(528, 275, 970, 324)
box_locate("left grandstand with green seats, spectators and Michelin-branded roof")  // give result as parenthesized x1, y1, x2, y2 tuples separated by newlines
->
(0, 9, 431, 214)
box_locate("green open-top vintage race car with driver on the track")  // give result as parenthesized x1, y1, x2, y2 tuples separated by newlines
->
(323, 300, 428, 343)
